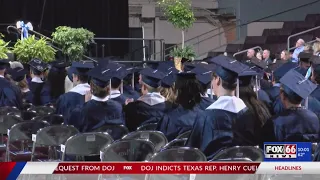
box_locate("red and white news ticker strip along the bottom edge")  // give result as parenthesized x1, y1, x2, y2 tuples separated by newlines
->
(0, 162, 320, 180)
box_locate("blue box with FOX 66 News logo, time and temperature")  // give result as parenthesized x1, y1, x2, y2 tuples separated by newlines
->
(264, 142, 312, 162)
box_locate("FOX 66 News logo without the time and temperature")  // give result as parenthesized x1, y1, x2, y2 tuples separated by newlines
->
(264, 144, 297, 159)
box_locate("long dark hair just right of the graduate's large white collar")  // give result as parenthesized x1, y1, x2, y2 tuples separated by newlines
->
(239, 85, 271, 127)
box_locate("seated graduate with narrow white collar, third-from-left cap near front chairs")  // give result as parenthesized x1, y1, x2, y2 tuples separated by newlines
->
(68, 66, 124, 132)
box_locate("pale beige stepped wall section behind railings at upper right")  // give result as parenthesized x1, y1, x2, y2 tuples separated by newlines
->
(247, 22, 283, 36)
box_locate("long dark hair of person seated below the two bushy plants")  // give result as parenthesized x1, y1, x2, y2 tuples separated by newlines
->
(47, 70, 67, 99)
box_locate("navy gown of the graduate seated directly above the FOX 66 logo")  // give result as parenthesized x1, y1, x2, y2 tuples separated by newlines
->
(264, 108, 320, 142)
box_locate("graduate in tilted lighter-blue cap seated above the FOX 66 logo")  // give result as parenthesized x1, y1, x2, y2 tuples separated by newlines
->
(264, 70, 319, 142)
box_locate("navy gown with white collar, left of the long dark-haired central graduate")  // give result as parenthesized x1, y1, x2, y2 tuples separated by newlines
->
(123, 93, 172, 131)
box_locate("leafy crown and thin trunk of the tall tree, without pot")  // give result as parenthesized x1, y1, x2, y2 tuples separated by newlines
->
(158, 0, 196, 49)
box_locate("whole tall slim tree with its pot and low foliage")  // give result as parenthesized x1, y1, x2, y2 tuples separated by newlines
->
(158, 0, 196, 70)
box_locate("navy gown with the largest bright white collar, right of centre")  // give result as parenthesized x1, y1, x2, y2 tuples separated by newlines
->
(187, 96, 247, 159)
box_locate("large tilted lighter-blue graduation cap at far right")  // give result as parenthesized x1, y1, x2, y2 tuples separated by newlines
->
(280, 69, 317, 99)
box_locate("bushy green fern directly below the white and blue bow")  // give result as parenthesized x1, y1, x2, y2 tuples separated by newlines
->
(13, 36, 56, 63)
